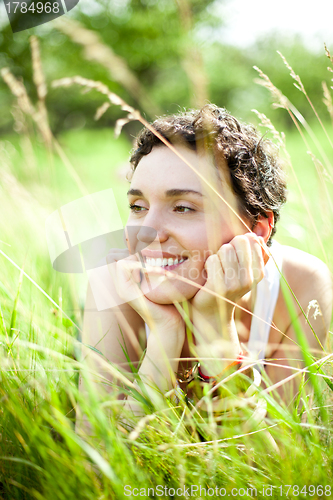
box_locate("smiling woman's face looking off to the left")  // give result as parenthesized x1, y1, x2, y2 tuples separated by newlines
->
(127, 146, 246, 304)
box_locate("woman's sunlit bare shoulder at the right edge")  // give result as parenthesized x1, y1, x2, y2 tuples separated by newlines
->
(282, 245, 333, 324)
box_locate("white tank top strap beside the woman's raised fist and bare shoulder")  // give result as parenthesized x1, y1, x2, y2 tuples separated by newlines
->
(145, 241, 283, 360)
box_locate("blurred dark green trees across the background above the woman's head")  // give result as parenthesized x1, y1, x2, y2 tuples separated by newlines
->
(0, 0, 331, 133)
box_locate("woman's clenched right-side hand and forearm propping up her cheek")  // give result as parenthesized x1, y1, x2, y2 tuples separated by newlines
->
(190, 233, 269, 375)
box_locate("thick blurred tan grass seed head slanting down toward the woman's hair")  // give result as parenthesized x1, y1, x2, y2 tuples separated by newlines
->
(54, 17, 161, 116)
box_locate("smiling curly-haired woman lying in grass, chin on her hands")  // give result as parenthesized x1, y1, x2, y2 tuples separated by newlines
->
(84, 105, 332, 411)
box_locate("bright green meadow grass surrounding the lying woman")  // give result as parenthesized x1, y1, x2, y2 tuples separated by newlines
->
(0, 119, 333, 500)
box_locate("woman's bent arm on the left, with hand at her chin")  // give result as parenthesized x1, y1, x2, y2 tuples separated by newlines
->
(81, 252, 185, 424)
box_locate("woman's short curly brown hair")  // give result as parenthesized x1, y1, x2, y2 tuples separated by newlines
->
(130, 104, 286, 244)
